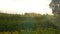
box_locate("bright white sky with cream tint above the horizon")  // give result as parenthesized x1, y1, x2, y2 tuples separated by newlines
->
(0, 0, 52, 14)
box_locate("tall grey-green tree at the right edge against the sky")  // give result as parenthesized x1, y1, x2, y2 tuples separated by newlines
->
(49, 0, 60, 15)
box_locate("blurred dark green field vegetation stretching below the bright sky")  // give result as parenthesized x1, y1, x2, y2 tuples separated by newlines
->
(0, 14, 60, 34)
